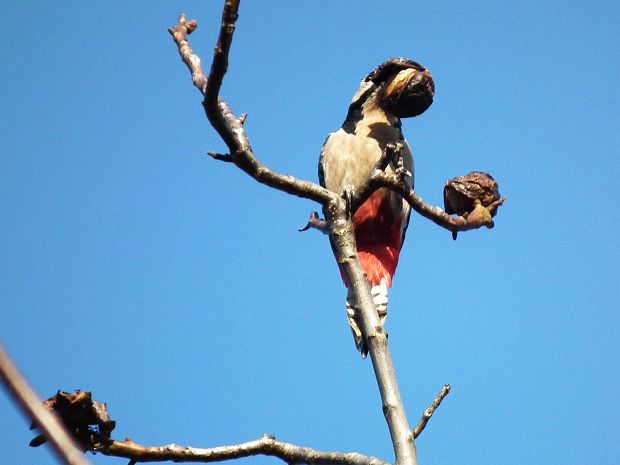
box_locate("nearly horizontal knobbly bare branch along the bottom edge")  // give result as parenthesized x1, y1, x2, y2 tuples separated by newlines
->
(93, 435, 388, 465)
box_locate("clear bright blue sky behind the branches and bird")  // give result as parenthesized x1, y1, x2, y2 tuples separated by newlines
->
(0, 0, 620, 465)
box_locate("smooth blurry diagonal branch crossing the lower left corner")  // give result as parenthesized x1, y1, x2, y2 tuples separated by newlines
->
(0, 344, 90, 465)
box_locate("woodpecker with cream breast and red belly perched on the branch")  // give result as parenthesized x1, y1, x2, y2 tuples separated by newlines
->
(319, 57, 435, 358)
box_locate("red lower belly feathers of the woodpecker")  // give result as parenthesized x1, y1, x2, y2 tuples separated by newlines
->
(340, 189, 405, 287)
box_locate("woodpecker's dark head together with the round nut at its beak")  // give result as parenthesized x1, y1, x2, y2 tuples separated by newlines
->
(364, 57, 435, 118)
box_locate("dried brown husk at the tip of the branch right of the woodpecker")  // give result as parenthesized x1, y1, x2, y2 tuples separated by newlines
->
(443, 171, 500, 216)
